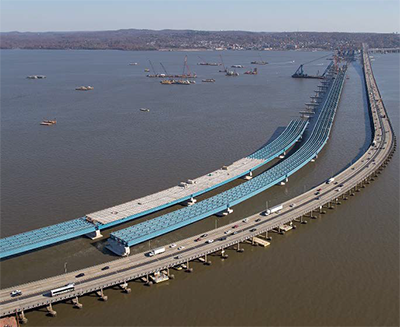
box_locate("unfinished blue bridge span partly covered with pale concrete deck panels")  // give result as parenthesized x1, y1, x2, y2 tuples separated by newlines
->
(0, 120, 308, 258)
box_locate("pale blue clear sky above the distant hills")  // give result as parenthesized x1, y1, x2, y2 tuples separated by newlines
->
(0, 0, 400, 33)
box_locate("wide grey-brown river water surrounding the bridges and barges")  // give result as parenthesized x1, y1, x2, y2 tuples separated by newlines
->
(1, 50, 400, 326)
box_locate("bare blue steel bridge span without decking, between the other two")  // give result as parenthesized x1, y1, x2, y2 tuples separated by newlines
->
(110, 67, 346, 246)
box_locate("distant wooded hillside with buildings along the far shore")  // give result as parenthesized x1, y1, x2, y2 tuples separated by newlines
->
(0, 29, 400, 50)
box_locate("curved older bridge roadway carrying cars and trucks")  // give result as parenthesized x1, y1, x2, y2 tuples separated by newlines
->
(0, 46, 395, 316)
